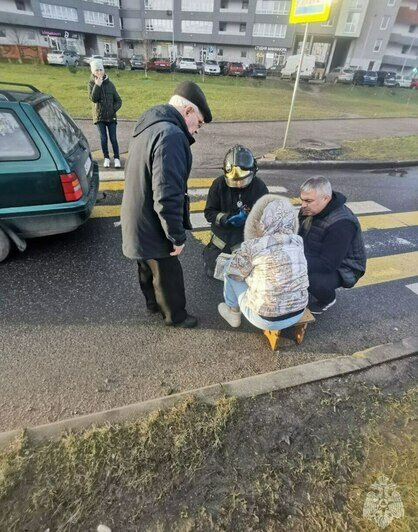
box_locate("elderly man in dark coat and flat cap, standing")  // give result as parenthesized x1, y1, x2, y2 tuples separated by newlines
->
(121, 81, 212, 328)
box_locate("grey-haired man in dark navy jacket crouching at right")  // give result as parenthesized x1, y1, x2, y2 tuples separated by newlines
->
(299, 176, 366, 314)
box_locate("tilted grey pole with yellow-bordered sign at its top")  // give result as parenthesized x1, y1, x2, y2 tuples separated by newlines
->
(283, 0, 332, 149)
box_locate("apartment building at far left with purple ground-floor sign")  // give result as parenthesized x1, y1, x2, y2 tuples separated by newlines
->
(0, 0, 121, 55)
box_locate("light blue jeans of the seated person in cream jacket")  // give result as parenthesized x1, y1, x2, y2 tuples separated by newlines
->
(224, 275, 303, 331)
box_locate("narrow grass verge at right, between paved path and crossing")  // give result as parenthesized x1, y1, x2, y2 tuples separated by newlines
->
(273, 135, 418, 161)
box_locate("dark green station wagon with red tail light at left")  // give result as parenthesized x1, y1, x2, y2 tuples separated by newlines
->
(0, 81, 99, 262)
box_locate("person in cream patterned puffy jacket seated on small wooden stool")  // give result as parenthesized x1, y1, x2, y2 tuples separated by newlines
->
(218, 194, 308, 330)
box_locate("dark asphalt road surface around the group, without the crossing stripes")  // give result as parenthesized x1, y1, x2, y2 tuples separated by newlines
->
(0, 168, 418, 430)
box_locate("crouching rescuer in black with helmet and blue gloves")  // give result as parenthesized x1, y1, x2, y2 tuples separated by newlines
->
(203, 144, 268, 277)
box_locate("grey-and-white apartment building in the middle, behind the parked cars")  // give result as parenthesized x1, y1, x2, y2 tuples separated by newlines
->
(120, 0, 294, 66)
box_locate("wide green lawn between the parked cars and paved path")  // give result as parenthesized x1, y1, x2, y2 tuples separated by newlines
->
(0, 63, 418, 120)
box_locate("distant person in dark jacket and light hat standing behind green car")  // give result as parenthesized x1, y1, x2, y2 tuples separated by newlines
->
(88, 59, 122, 168)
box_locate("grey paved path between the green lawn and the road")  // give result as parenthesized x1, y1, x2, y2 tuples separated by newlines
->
(78, 118, 418, 169)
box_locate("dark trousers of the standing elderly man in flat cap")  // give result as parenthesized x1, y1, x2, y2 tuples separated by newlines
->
(138, 257, 187, 325)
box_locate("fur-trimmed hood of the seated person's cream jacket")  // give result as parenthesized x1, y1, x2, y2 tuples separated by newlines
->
(244, 194, 299, 241)
